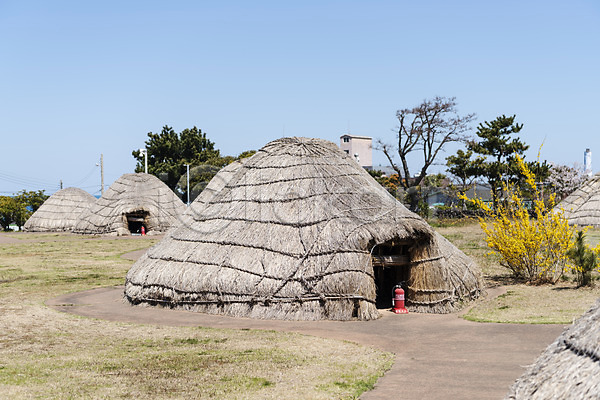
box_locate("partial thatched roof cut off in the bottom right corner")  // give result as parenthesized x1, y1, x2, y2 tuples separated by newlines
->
(506, 300, 600, 400)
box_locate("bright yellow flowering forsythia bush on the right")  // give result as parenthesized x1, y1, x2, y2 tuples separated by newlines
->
(461, 156, 576, 283)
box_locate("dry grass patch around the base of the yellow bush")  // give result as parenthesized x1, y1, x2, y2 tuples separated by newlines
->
(436, 222, 600, 324)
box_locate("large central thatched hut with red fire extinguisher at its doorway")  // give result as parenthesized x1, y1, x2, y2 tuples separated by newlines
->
(125, 138, 482, 320)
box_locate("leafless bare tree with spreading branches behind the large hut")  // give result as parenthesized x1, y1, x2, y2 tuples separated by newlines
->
(377, 96, 475, 189)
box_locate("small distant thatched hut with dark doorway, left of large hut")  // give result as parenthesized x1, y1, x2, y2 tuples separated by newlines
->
(73, 173, 185, 235)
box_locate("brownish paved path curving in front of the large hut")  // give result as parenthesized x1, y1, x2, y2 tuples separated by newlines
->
(46, 287, 564, 400)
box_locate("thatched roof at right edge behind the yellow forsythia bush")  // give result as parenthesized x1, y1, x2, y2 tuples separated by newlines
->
(557, 173, 600, 226)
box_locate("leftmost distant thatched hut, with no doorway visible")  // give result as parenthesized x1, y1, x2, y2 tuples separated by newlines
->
(23, 188, 96, 232)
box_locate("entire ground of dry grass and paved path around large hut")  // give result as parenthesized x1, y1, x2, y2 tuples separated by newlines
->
(0, 224, 600, 399)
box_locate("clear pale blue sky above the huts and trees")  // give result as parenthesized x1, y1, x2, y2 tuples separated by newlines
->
(0, 0, 600, 194)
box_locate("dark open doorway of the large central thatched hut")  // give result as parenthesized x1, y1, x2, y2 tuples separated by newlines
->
(371, 240, 412, 308)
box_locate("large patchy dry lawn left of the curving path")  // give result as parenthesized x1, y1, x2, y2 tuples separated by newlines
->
(0, 234, 393, 399)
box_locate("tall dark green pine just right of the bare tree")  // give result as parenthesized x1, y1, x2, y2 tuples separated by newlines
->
(467, 115, 529, 207)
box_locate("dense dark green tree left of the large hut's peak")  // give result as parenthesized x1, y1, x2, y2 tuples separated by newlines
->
(131, 125, 221, 197)
